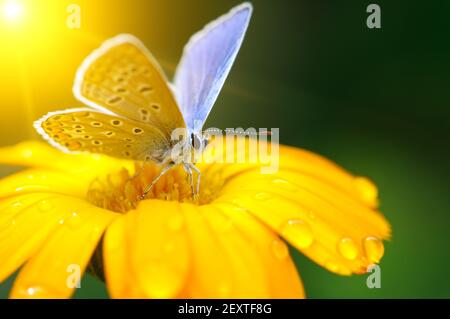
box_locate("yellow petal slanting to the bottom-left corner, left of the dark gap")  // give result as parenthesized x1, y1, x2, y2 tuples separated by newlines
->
(9, 197, 116, 298)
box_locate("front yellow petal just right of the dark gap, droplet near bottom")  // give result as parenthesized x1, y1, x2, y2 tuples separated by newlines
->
(104, 200, 189, 298)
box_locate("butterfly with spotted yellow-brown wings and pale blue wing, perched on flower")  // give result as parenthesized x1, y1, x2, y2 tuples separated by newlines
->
(34, 3, 252, 198)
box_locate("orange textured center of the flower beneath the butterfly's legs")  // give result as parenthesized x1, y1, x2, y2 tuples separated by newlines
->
(87, 163, 223, 213)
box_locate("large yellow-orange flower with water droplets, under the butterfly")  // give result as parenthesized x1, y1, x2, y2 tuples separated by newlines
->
(0, 141, 390, 298)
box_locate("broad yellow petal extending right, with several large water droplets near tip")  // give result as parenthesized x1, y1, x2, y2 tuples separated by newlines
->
(217, 170, 390, 275)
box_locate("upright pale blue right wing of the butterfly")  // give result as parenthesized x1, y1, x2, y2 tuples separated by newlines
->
(174, 3, 252, 132)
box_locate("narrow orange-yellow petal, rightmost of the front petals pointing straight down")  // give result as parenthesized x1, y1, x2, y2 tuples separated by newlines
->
(212, 203, 305, 298)
